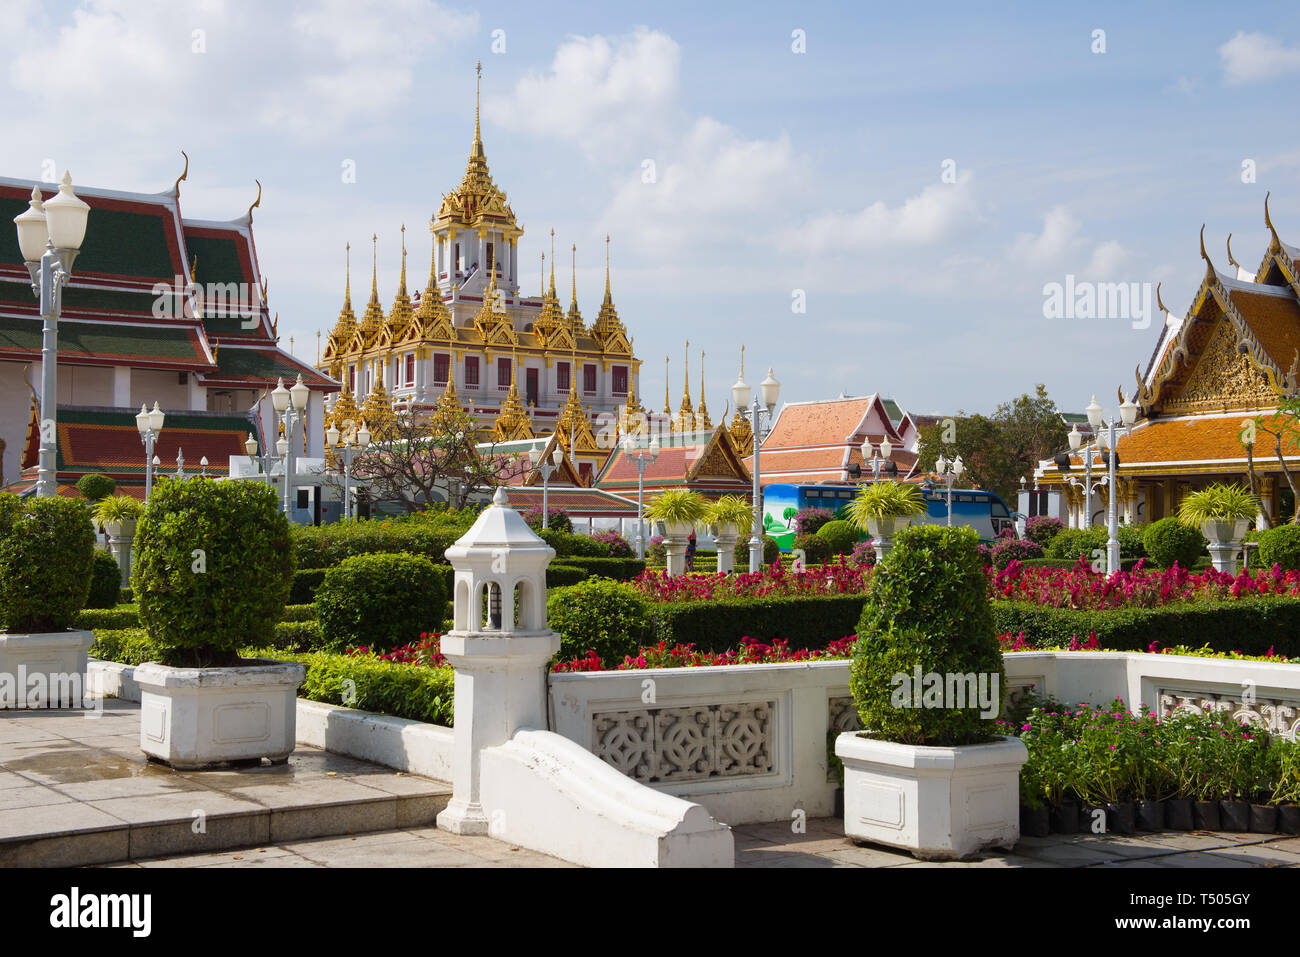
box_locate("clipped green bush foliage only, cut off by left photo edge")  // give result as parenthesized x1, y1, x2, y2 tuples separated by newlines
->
(0, 493, 95, 633)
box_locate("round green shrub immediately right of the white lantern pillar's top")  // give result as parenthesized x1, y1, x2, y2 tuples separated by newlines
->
(546, 577, 649, 668)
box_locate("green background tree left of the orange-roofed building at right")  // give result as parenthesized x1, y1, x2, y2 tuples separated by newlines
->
(919, 384, 1066, 501)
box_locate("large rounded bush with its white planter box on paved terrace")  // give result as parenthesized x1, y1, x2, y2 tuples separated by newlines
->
(131, 479, 306, 768)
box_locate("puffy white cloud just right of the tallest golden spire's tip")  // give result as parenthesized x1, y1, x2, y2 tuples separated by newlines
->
(484, 26, 681, 156)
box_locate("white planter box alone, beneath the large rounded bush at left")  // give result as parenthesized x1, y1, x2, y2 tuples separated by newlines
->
(135, 661, 307, 770)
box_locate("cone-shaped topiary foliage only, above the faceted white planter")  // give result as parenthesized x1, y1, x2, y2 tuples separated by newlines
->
(849, 525, 1006, 746)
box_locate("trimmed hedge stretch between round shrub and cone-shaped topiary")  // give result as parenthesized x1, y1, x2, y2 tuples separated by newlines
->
(646, 594, 866, 651)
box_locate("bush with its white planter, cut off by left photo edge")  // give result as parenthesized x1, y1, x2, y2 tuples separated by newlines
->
(0, 493, 95, 709)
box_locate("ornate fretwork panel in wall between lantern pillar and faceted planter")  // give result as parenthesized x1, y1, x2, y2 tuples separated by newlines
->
(592, 701, 776, 784)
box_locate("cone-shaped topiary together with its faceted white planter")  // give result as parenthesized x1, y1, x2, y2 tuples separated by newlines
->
(835, 525, 1028, 859)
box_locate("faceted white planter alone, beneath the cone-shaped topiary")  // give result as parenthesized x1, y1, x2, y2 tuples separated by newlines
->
(835, 732, 1028, 861)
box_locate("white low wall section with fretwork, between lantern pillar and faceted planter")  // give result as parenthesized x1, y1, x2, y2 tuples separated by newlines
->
(549, 661, 859, 824)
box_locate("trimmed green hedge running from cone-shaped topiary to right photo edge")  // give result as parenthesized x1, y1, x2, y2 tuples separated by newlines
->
(992, 598, 1300, 658)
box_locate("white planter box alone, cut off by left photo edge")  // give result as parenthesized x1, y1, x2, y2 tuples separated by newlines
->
(0, 631, 95, 710)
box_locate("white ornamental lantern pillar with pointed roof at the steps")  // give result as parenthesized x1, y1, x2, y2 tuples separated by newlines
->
(438, 489, 560, 835)
